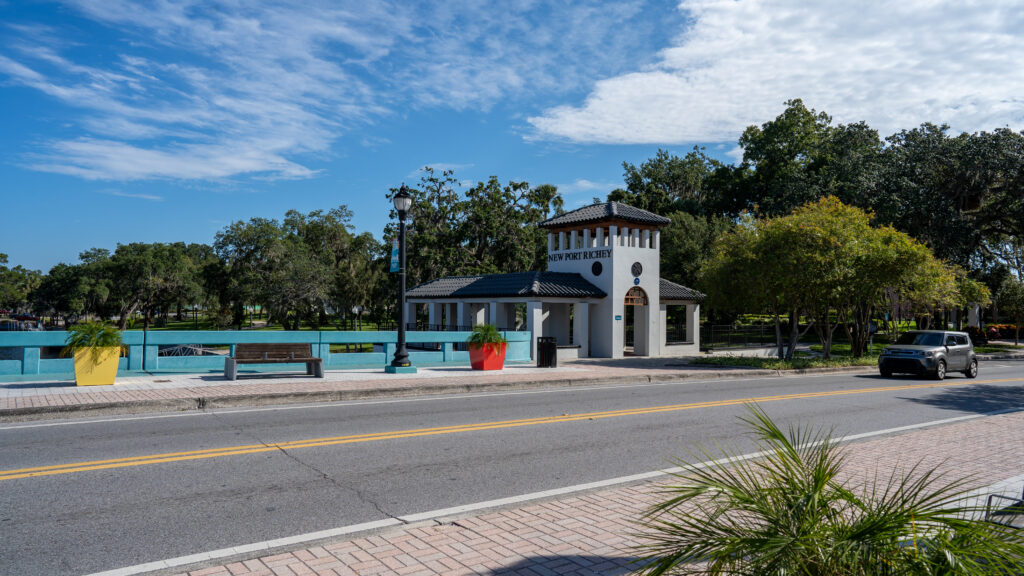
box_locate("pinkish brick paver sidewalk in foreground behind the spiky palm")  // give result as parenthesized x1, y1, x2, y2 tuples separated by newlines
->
(151, 413, 1024, 576)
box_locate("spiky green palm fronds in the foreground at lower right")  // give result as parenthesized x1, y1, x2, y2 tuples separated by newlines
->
(639, 407, 1024, 576)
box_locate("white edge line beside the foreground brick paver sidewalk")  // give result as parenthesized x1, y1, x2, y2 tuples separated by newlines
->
(79, 407, 1024, 576)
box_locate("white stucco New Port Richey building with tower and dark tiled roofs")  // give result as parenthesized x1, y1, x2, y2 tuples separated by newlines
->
(407, 202, 703, 358)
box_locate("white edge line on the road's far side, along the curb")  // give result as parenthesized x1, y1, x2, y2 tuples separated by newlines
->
(0, 372, 880, 430)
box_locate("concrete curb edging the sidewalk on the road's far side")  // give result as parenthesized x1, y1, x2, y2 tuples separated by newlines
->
(0, 366, 874, 422)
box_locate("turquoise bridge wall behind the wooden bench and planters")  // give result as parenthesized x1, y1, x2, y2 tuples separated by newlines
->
(0, 330, 530, 378)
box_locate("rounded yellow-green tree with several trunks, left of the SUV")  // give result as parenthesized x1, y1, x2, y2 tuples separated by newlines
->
(702, 197, 955, 360)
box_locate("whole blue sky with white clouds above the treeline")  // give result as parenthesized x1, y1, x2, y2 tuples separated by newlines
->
(0, 0, 1024, 271)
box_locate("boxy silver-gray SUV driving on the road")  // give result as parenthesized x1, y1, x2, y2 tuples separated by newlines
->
(879, 330, 978, 380)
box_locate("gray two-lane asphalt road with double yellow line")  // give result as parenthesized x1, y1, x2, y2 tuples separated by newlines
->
(0, 361, 1024, 575)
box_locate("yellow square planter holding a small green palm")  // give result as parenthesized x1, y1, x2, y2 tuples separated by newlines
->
(63, 322, 121, 386)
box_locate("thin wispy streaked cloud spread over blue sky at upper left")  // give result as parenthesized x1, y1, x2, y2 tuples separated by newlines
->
(0, 0, 671, 180)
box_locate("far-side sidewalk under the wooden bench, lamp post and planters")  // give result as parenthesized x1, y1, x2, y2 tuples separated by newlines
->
(0, 358, 873, 421)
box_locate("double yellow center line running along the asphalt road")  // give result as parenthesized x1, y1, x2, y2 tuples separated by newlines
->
(0, 378, 1024, 481)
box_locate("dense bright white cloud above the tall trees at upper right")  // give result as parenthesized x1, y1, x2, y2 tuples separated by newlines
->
(528, 0, 1024, 145)
